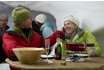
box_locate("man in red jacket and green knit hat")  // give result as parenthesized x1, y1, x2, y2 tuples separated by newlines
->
(3, 7, 45, 70)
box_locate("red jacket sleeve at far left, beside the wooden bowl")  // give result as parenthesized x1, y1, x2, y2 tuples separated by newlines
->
(3, 33, 22, 56)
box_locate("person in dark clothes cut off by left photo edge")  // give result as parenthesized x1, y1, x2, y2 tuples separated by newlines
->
(0, 14, 9, 63)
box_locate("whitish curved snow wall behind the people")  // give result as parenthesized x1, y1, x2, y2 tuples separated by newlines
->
(3, 1, 104, 55)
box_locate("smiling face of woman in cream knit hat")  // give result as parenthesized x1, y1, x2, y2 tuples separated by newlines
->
(64, 20, 77, 34)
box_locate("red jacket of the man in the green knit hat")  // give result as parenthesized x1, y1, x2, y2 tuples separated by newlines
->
(3, 27, 44, 56)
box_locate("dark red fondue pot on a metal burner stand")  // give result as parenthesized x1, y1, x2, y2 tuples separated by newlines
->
(66, 43, 86, 51)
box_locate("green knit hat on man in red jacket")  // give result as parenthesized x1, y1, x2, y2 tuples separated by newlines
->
(12, 7, 31, 27)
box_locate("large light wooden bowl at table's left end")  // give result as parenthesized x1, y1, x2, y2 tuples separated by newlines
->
(13, 48, 44, 64)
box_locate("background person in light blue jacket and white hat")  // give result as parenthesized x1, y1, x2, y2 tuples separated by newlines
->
(33, 14, 56, 38)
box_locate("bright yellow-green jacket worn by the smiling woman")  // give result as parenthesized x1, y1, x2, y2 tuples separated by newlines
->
(62, 29, 102, 56)
